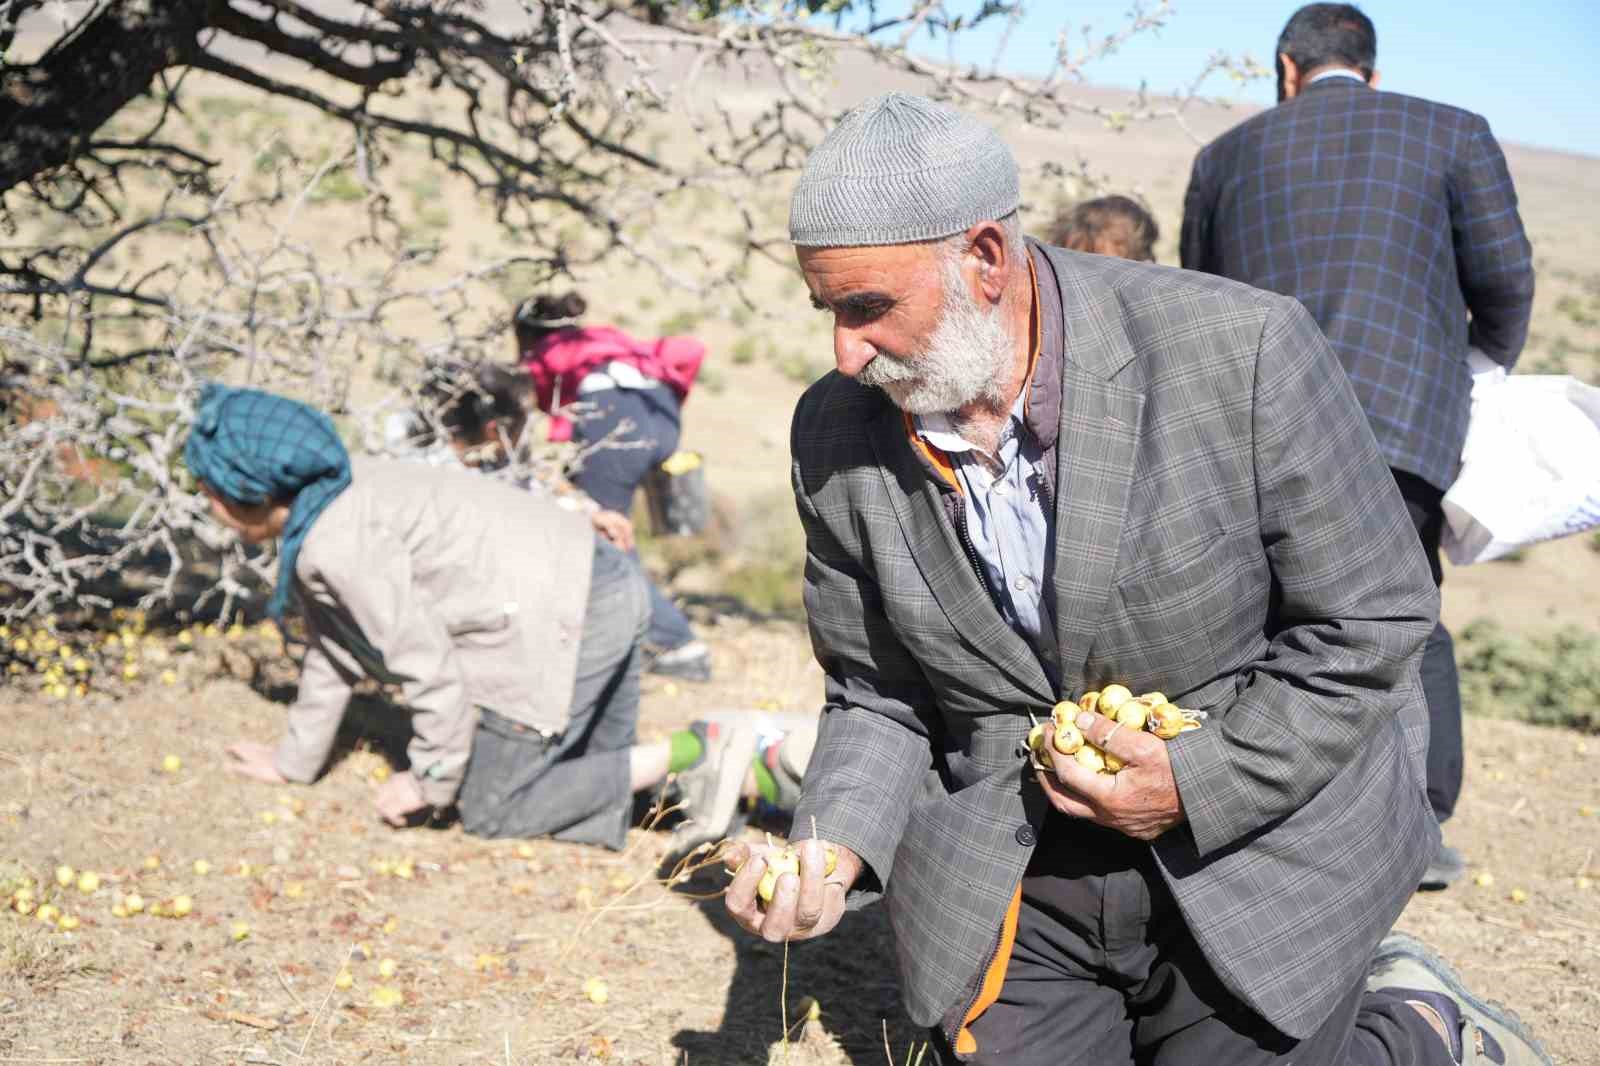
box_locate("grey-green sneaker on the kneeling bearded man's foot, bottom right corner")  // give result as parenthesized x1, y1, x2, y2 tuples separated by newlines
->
(1366, 933, 1555, 1066)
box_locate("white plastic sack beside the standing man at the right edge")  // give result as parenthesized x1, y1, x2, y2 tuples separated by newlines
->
(1440, 352, 1600, 567)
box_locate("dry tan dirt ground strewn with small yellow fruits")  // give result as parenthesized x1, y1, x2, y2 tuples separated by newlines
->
(0, 619, 1600, 1066)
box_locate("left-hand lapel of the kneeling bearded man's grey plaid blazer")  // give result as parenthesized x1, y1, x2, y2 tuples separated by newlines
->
(872, 398, 1056, 706)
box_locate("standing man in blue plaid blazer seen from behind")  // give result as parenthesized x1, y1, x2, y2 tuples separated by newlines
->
(1181, 3, 1533, 888)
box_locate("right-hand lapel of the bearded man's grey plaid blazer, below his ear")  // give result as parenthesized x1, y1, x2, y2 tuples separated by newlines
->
(1042, 248, 1144, 696)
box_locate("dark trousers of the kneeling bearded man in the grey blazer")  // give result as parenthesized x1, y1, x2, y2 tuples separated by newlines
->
(931, 815, 1456, 1066)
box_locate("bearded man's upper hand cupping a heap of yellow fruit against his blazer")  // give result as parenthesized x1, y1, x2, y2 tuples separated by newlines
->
(1035, 711, 1184, 840)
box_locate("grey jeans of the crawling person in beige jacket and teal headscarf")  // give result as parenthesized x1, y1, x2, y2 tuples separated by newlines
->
(458, 538, 650, 850)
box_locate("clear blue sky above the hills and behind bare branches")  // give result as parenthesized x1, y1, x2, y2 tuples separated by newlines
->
(915, 0, 1600, 155)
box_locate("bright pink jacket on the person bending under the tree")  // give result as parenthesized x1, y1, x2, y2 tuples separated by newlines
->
(522, 327, 706, 440)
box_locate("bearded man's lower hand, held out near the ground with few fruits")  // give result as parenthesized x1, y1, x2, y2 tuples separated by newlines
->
(723, 840, 861, 944)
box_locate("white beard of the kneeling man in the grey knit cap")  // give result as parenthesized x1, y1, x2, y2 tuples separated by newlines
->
(856, 253, 1014, 415)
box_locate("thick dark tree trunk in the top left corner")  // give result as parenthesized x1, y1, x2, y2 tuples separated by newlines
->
(0, 0, 211, 192)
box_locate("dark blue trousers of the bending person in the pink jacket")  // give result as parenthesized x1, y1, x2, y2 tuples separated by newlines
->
(571, 386, 694, 651)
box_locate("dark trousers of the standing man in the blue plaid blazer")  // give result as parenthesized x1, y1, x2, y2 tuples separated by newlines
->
(1390, 469, 1464, 824)
